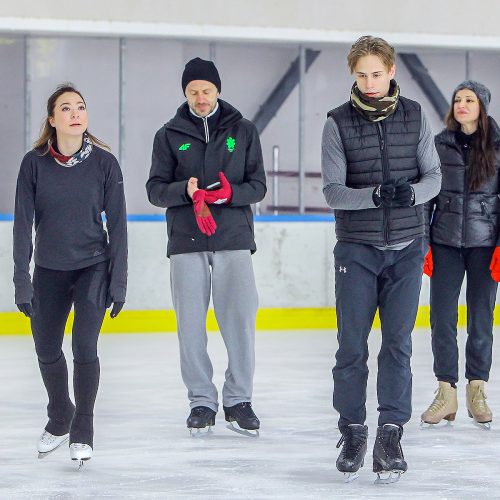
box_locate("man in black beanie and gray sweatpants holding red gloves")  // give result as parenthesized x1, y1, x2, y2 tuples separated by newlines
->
(146, 57, 266, 434)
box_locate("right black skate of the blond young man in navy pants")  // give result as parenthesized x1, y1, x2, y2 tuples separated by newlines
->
(373, 424, 408, 484)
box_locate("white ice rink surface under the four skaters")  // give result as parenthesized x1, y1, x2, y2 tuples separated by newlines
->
(0, 330, 500, 500)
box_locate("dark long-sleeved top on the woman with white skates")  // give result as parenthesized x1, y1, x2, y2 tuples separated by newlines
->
(14, 146, 127, 304)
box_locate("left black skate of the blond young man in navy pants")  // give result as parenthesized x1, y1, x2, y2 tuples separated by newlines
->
(336, 424, 368, 483)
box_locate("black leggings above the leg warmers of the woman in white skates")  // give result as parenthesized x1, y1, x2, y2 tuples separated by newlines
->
(31, 261, 109, 363)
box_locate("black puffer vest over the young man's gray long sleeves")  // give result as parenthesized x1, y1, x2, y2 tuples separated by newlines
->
(328, 97, 424, 246)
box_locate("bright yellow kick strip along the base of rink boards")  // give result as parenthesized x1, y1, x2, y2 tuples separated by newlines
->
(0, 305, 500, 335)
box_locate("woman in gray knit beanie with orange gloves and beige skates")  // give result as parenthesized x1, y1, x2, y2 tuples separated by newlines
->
(421, 80, 500, 428)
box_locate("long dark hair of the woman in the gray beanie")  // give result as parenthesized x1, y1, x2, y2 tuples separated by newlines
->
(444, 96, 496, 191)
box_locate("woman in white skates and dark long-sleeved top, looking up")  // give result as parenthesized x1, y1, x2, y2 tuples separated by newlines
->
(14, 83, 127, 465)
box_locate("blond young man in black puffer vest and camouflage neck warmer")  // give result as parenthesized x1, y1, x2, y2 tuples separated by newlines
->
(322, 36, 441, 482)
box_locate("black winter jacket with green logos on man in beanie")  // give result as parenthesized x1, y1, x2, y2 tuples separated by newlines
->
(146, 99, 266, 256)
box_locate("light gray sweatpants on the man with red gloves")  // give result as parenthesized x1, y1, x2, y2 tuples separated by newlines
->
(170, 250, 258, 411)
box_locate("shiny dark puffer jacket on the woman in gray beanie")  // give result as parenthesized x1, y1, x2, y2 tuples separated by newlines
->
(430, 117, 500, 248)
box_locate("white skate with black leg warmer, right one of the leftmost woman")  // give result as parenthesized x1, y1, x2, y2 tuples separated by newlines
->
(69, 359, 100, 469)
